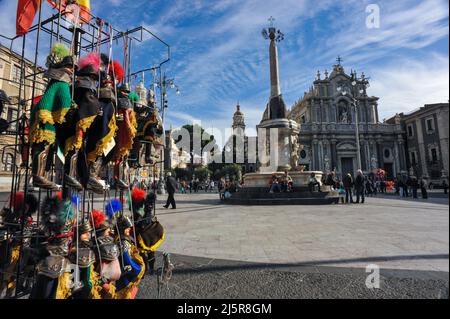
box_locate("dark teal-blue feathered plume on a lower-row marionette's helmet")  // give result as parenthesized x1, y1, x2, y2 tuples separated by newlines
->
(41, 196, 73, 235)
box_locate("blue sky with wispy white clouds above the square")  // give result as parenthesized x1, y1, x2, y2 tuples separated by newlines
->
(0, 0, 449, 145)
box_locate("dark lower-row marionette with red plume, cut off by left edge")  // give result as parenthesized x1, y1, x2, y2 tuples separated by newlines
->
(0, 192, 39, 298)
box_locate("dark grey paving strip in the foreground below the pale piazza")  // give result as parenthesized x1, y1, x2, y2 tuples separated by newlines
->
(137, 255, 449, 299)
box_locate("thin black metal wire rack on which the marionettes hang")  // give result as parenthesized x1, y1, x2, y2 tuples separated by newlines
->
(0, 1, 170, 298)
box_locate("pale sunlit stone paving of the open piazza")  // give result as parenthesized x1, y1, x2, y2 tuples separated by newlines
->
(157, 193, 449, 272)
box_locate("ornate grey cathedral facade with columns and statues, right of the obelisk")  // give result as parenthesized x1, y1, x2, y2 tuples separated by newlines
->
(289, 58, 407, 178)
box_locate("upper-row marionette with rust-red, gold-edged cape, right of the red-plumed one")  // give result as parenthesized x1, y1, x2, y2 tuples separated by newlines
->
(114, 83, 137, 189)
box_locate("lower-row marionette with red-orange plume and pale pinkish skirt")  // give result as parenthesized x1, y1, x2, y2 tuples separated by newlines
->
(92, 209, 122, 299)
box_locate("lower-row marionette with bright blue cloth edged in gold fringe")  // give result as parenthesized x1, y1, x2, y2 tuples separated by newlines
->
(115, 215, 145, 299)
